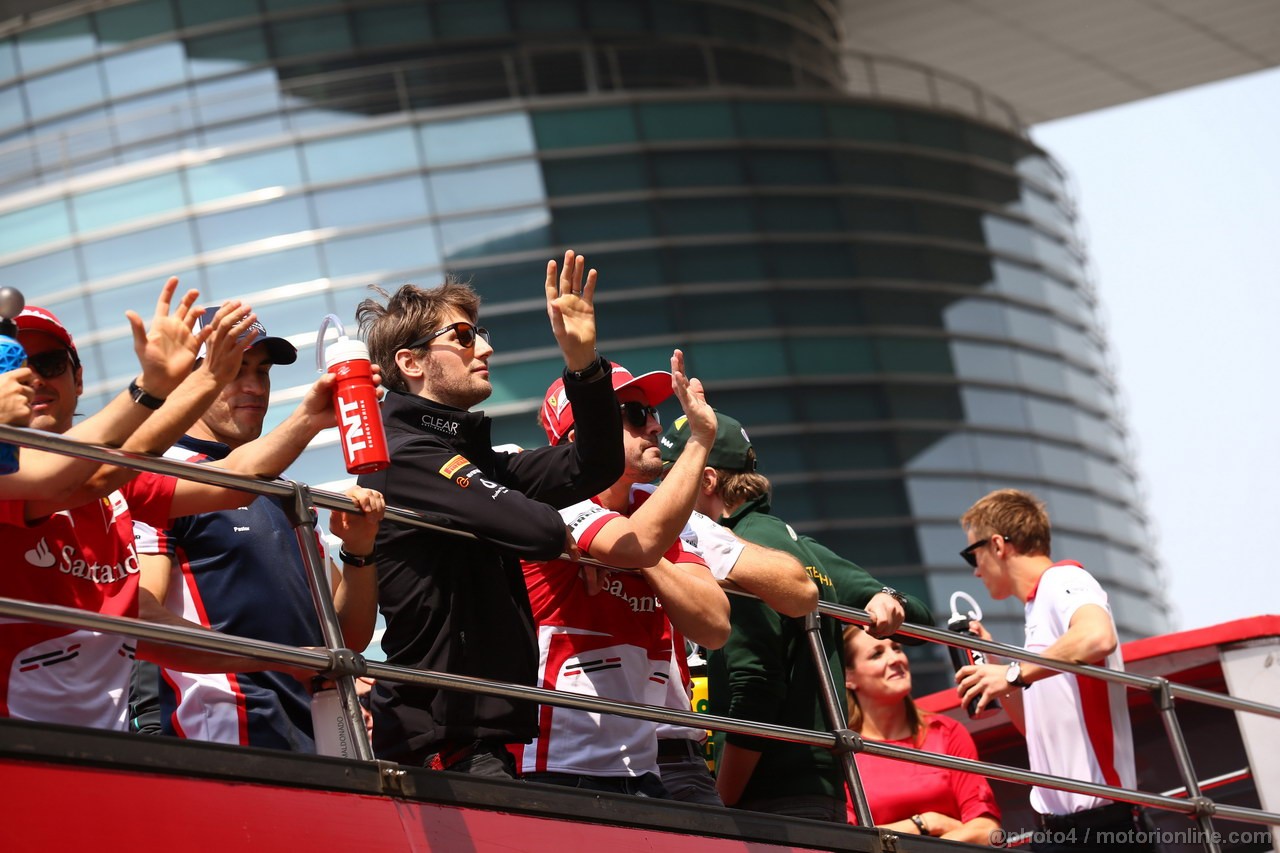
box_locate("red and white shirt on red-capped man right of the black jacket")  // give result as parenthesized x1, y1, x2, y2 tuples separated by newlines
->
(515, 481, 705, 776)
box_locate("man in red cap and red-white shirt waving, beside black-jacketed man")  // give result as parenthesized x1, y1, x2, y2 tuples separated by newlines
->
(509, 350, 728, 798)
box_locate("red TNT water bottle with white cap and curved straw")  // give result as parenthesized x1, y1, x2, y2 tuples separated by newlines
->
(316, 314, 390, 474)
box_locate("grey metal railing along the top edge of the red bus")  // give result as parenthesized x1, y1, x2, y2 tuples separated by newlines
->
(0, 425, 1280, 852)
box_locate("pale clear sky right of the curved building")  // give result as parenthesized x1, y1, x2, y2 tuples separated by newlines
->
(1032, 69, 1280, 629)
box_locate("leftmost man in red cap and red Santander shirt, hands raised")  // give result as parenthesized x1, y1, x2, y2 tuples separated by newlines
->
(0, 279, 264, 729)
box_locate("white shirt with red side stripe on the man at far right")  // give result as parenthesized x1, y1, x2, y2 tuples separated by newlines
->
(1023, 561, 1137, 815)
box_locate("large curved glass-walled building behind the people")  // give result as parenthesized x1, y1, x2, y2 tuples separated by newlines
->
(0, 0, 1169, 676)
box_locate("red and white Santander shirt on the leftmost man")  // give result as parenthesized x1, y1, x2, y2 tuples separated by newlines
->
(0, 473, 175, 731)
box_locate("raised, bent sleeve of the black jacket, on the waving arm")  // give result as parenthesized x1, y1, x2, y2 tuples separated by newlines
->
(497, 362, 623, 507)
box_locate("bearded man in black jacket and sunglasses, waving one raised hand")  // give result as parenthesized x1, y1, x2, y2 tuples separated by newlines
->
(356, 251, 622, 776)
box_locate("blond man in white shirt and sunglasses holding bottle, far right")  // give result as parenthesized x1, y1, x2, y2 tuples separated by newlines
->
(956, 489, 1149, 850)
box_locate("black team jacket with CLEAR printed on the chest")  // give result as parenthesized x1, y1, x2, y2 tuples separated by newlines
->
(358, 361, 623, 763)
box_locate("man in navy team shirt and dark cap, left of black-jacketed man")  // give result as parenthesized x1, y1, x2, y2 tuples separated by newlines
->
(129, 315, 384, 752)
